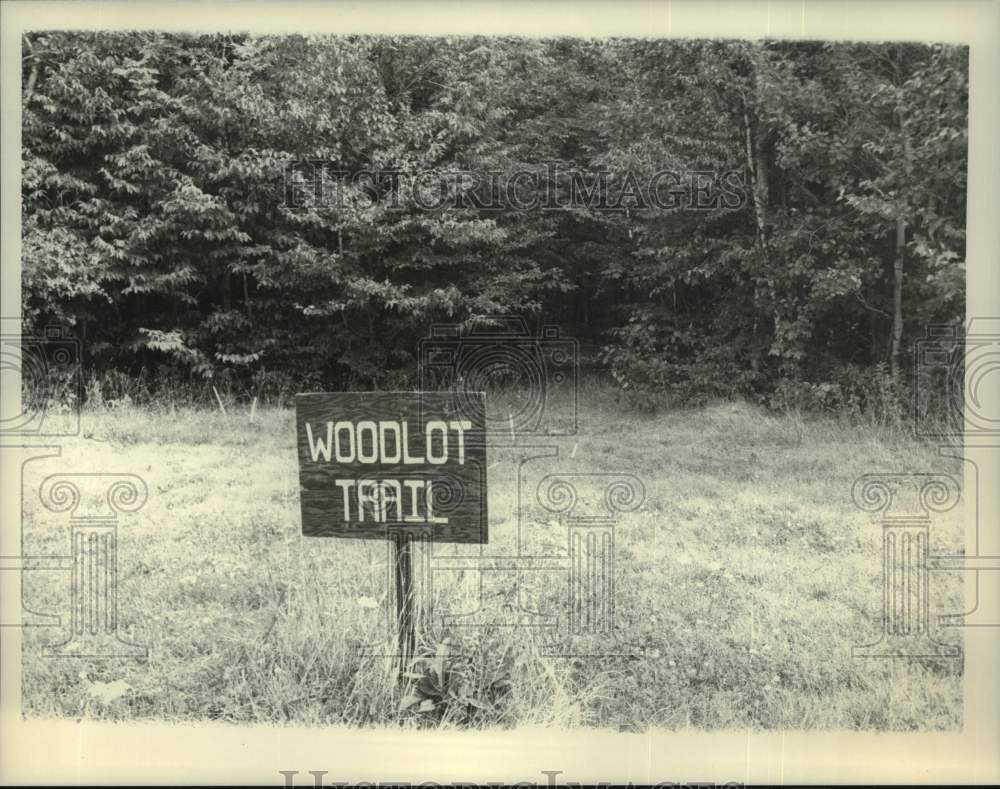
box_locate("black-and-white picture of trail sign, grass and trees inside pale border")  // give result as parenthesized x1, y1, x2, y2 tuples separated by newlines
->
(0, 3, 1000, 786)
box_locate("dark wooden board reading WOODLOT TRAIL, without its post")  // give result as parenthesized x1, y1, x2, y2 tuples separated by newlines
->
(295, 392, 487, 543)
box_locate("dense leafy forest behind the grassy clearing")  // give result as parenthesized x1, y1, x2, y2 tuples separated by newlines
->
(22, 31, 968, 413)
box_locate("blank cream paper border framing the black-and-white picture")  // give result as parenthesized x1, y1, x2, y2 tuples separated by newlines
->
(0, 0, 1000, 785)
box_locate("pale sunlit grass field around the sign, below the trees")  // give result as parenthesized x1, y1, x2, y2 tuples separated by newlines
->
(23, 393, 963, 730)
